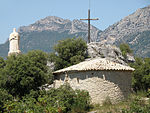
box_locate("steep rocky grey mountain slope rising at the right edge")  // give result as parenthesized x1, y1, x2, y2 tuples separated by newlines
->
(99, 6, 150, 57)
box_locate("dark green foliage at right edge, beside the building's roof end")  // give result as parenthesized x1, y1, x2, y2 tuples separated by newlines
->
(130, 58, 150, 91)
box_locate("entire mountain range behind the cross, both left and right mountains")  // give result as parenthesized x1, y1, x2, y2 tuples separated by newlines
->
(0, 6, 150, 57)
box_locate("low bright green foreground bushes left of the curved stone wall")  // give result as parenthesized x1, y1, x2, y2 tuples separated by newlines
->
(5, 85, 90, 113)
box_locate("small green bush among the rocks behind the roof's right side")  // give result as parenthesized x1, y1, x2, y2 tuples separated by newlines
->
(120, 43, 133, 58)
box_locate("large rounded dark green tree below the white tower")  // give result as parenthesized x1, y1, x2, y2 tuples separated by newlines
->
(0, 50, 51, 97)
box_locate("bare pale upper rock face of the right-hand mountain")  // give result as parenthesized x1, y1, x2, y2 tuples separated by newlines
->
(100, 6, 150, 44)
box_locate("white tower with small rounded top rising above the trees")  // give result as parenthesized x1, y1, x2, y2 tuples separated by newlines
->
(8, 28, 21, 56)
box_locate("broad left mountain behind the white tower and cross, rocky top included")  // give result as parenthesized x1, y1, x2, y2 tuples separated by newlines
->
(0, 16, 101, 57)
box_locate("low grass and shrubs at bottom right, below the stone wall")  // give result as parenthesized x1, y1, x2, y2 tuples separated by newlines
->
(92, 92, 150, 113)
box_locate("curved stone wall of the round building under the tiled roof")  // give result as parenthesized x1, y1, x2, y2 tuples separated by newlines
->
(54, 71, 131, 104)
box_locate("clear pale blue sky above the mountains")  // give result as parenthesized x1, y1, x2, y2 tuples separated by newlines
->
(0, 0, 150, 43)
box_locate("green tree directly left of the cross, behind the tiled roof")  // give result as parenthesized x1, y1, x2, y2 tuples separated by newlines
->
(49, 38, 87, 70)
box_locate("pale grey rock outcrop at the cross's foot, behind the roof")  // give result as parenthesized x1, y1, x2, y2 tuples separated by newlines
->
(87, 42, 135, 65)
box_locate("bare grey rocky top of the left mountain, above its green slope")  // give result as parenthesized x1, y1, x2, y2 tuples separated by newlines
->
(18, 16, 101, 41)
